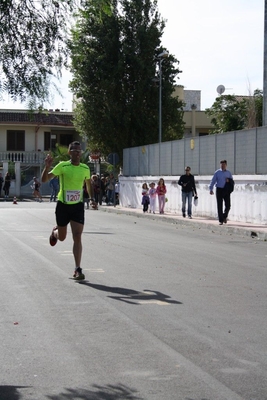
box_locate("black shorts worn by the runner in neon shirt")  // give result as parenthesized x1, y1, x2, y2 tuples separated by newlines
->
(55, 201, 84, 226)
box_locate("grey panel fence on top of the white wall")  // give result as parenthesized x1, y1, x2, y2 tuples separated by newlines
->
(123, 126, 267, 176)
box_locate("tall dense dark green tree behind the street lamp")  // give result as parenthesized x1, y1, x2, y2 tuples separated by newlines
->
(69, 0, 183, 159)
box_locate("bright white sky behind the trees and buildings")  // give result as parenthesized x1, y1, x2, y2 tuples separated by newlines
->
(0, 0, 264, 111)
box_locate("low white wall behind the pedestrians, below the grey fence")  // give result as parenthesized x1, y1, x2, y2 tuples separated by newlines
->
(119, 175, 267, 225)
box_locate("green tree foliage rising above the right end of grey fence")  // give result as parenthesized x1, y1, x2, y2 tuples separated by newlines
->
(206, 89, 263, 133)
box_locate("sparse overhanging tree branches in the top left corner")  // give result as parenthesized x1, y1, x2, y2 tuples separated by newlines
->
(0, 0, 110, 106)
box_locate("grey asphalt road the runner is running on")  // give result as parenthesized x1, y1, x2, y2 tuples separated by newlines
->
(0, 202, 267, 400)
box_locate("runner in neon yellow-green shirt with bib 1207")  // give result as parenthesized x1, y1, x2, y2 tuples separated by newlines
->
(42, 141, 96, 280)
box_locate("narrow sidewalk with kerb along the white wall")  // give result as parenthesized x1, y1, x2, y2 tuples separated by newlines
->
(99, 205, 267, 241)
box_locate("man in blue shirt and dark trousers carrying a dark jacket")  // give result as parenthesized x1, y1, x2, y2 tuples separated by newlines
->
(209, 160, 234, 225)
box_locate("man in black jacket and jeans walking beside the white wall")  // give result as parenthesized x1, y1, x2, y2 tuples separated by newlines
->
(178, 167, 197, 219)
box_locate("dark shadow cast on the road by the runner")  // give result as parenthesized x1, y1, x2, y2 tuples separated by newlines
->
(82, 282, 183, 305)
